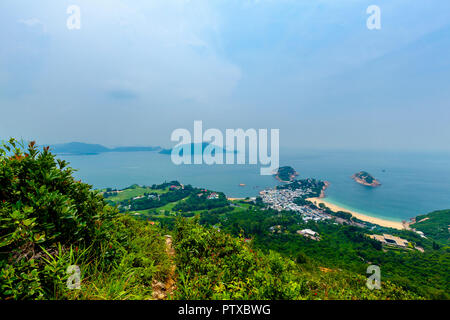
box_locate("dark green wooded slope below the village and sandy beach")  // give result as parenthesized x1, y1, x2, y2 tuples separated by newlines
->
(199, 207, 450, 299)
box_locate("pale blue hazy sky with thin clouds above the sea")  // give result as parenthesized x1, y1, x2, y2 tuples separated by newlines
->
(0, 0, 450, 151)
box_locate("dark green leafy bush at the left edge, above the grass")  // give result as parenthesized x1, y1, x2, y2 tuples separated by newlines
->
(0, 139, 116, 254)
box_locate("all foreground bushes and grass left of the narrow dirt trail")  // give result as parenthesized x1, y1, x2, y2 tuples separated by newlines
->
(0, 140, 170, 299)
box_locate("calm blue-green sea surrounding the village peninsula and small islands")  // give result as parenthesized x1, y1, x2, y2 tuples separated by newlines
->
(59, 150, 450, 221)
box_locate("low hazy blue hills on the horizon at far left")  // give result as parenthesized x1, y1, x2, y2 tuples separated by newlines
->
(50, 142, 161, 155)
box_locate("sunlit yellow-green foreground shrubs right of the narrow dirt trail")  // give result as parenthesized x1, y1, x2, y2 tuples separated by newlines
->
(175, 220, 419, 300)
